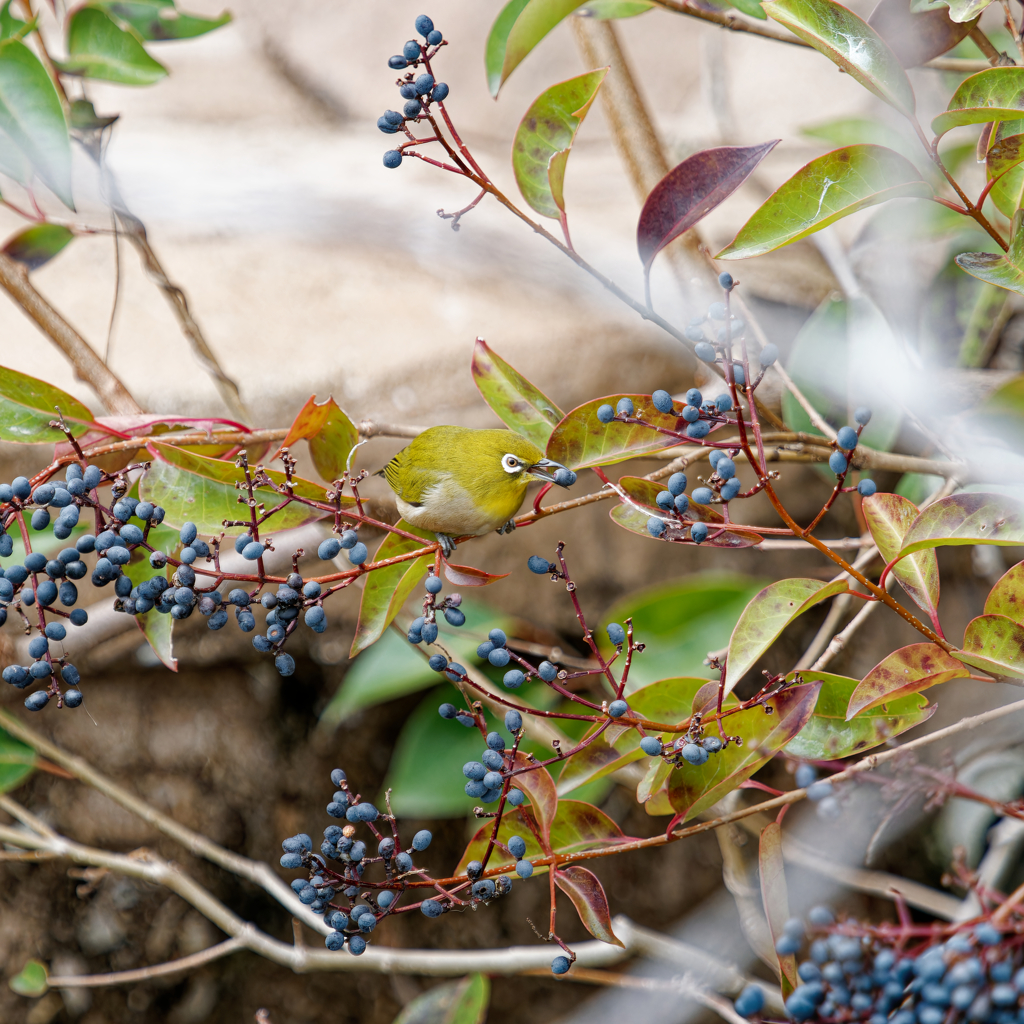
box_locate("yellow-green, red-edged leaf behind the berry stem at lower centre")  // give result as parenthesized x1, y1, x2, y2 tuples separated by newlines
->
(455, 794, 632, 876)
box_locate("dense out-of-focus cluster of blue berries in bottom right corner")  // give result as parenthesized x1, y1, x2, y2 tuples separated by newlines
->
(734, 907, 1024, 1024)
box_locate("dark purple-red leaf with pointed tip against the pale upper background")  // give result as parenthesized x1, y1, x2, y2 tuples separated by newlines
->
(637, 144, 780, 272)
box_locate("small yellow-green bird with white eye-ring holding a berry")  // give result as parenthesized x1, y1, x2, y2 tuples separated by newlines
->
(379, 426, 575, 558)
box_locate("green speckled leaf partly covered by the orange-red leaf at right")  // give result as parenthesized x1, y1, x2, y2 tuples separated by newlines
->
(785, 672, 938, 761)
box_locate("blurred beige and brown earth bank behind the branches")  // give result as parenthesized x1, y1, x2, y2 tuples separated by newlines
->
(0, 0, 1024, 1024)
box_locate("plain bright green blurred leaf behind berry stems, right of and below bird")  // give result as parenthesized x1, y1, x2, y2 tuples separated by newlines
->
(595, 572, 764, 688)
